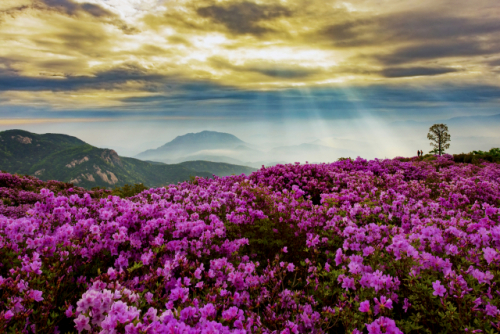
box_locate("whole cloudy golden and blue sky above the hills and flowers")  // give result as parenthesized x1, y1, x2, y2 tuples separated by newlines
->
(0, 0, 500, 158)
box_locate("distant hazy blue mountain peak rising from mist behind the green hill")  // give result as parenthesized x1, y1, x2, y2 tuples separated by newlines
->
(135, 131, 245, 161)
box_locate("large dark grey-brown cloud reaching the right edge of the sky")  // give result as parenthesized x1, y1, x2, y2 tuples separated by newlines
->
(318, 11, 500, 67)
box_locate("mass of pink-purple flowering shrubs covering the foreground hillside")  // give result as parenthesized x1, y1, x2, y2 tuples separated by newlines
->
(0, 156, 500, 334)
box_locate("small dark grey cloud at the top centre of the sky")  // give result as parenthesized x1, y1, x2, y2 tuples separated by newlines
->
(197, 1, 291, 36)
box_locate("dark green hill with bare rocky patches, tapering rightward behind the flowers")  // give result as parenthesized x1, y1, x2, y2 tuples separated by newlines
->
(0, 130, 255, 188)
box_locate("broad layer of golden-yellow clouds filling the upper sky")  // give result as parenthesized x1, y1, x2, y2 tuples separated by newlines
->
(0, 0, 500, 108)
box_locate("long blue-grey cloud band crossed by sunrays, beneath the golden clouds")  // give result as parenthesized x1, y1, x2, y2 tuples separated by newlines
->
(122, 82, 500, 113)
